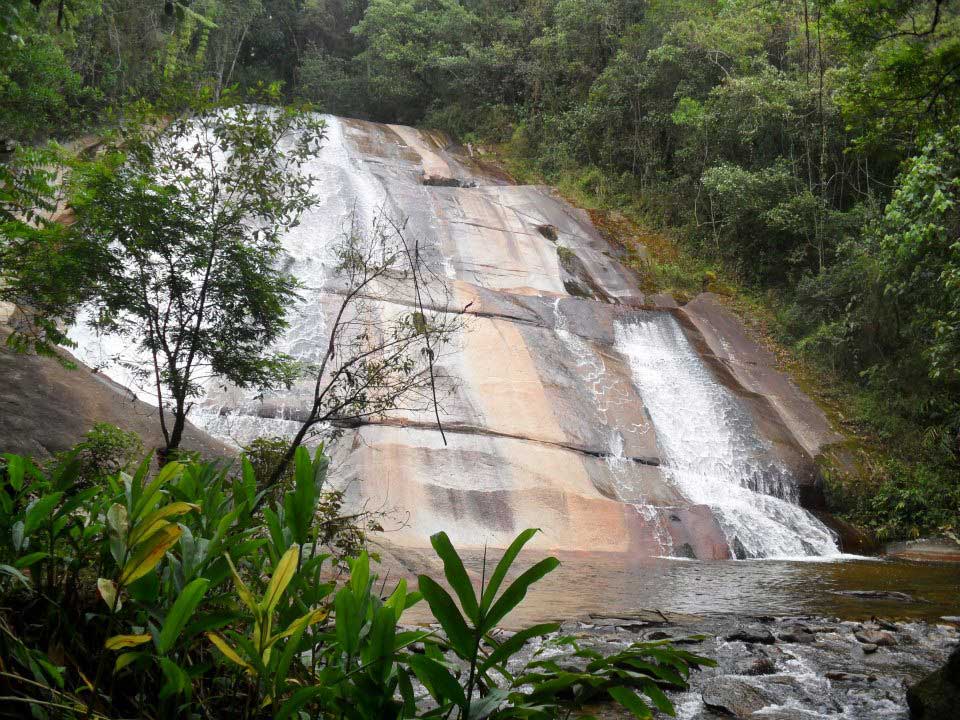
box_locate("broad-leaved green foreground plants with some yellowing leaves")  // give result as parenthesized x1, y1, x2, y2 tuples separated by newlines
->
(0, 442, 712, 719)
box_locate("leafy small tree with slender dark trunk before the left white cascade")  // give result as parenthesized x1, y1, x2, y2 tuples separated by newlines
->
(3, 91, 324, 460)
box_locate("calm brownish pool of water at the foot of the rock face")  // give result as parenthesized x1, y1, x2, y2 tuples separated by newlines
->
(381, 547, 960, 627)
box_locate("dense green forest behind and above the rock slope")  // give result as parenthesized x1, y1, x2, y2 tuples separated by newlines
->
(0, 0, 960, 535)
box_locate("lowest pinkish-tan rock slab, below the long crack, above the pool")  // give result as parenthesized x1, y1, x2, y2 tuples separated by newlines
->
(333, 425, 726, 558)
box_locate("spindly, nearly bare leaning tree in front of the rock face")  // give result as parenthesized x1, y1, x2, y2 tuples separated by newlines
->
(256, 209, 466, 485)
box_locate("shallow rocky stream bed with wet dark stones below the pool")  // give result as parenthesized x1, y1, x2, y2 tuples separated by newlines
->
(524, 613, 960, 720)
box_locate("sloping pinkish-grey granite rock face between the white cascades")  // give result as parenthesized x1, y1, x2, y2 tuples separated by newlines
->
(3, 117, 848, 559)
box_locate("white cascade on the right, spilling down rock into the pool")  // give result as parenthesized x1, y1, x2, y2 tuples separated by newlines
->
(616, 312, 838, 558)
